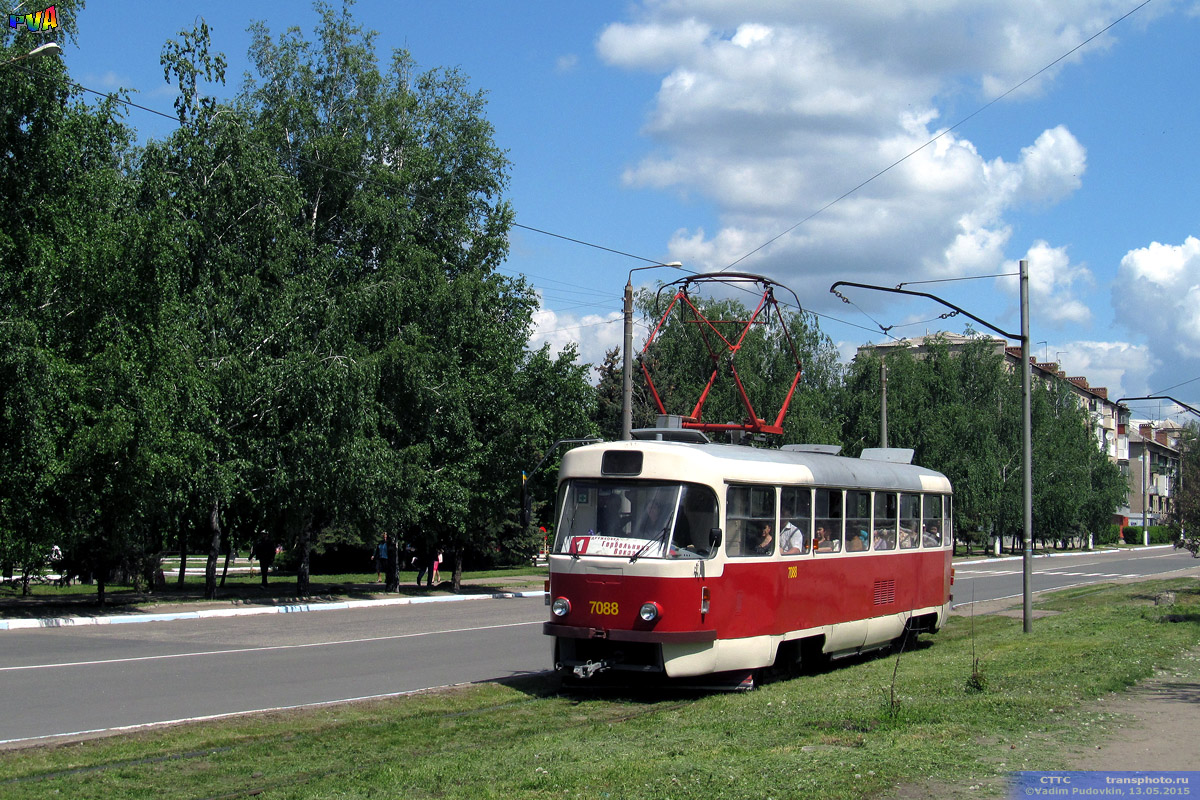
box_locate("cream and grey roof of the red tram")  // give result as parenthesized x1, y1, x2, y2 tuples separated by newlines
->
(563, 440, 950, 492)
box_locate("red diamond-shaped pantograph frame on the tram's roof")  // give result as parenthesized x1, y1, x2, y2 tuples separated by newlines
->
(641, 272, 803, 434)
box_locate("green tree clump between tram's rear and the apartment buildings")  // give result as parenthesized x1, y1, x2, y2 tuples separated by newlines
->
(842, 338, 1124, 547)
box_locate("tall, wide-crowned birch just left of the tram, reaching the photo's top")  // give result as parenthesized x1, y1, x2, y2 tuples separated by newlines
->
(232, 4, 583, 591)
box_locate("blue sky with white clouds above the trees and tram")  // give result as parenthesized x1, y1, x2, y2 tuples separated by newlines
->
(37, 0, 1200, 417)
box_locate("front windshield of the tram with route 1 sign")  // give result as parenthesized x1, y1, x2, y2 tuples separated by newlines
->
(554, 479, 718, 560)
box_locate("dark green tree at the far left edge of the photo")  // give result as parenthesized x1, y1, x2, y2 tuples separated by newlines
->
(0, 2, 169, 601)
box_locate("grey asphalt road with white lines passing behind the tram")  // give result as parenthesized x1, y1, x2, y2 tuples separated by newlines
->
(0, 548, 1200, 746)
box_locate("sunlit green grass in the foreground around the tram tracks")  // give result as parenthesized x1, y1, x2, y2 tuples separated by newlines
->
(0, 581, 1200, 800)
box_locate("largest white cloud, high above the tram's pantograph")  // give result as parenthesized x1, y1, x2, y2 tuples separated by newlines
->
(598, 0, 1108, 311)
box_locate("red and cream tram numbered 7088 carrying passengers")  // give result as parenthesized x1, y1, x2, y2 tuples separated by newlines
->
(544, 429, 952, 682)
